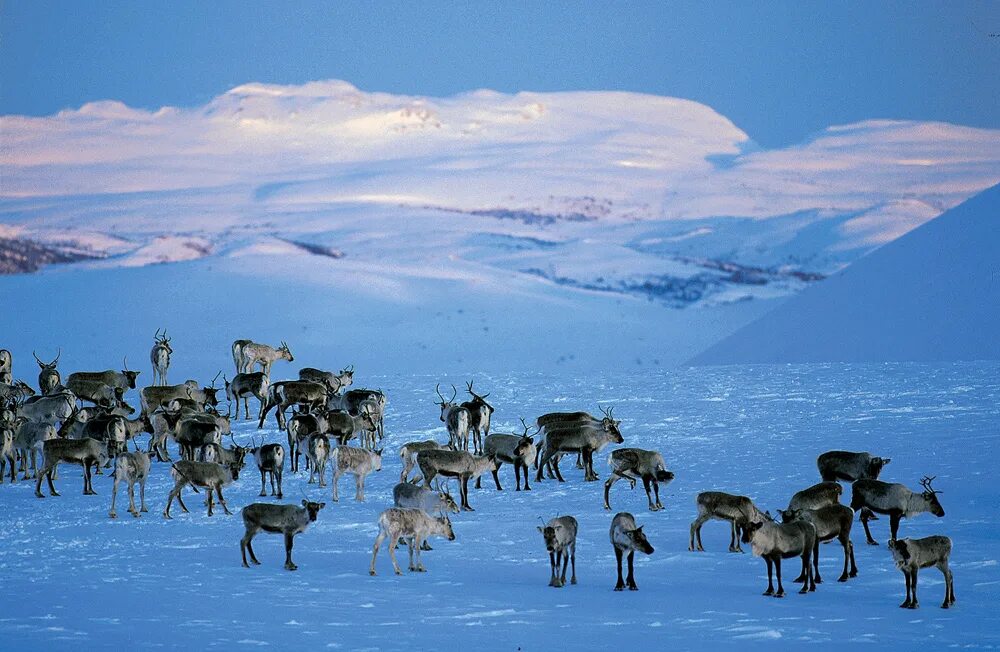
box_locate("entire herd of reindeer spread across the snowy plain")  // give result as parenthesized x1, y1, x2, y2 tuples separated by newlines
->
(0, 338, 955, 609)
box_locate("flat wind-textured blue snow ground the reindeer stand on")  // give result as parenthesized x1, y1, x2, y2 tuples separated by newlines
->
(0, 362, 1000, 651)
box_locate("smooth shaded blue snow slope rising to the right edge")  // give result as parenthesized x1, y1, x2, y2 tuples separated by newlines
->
(694, 186, 1000, 364)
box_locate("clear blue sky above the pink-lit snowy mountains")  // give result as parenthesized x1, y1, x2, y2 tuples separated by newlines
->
(0, 0, 1000, 147)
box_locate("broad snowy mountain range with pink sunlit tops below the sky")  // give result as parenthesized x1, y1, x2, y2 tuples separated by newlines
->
(0, 81, 1000, 307)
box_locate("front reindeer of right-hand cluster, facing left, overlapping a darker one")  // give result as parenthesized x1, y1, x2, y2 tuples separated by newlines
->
(743, 519, 817, 598)
